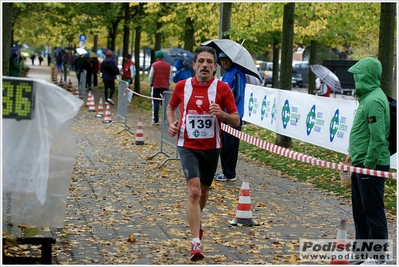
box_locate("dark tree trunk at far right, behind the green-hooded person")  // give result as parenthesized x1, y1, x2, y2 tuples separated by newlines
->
(378, 3, 396, 97)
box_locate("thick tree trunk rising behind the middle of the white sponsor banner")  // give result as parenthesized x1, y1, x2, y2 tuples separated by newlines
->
(276, 3, 295, 148)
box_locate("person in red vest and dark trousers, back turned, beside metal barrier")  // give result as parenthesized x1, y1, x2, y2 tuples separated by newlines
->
(148, 50, 171, 125)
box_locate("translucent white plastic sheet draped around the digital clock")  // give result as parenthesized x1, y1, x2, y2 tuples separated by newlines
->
(2, 77, 83, 227)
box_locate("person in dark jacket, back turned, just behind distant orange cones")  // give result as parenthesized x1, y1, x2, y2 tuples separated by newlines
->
(100, 50, 119, 105)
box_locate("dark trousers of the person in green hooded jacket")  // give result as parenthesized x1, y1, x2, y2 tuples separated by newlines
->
(351, 164, 389, 239)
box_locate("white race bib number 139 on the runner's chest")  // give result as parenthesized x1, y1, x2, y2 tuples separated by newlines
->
(187, 114, 216, 139)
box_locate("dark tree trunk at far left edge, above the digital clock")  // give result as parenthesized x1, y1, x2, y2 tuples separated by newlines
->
(2, 3, 14, 76)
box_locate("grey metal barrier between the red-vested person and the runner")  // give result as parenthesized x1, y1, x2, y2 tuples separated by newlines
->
(149, 91, 180, 168)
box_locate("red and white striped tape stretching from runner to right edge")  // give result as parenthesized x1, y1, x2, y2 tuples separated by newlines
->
(221, 123, 396, 179)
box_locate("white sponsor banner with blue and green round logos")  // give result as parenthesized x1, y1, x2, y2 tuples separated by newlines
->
(243, 84, 396, 169)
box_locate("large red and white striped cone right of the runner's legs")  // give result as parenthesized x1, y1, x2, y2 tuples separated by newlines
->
(229, 174, 254, 226)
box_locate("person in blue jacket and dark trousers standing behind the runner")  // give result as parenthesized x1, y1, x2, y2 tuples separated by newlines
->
(215, 52, 247, 182)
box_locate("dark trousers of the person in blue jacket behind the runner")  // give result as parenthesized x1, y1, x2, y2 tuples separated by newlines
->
(220, 119, 242, 178)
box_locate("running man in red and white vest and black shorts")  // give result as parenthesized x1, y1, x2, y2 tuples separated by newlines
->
(166, 46, 240, 261)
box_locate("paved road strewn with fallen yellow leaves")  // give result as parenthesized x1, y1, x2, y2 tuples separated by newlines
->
(22, 62, 397, 265)
